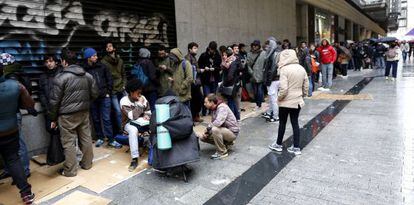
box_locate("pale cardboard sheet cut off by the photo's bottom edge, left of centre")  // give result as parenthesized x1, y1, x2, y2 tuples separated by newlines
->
(55, 191, 111, 205)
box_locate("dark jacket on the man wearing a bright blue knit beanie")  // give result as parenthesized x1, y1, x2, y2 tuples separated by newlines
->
(83, 62, 113, 98)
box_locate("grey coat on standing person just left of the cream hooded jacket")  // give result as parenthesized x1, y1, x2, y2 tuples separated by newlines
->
(247, 50, 266, 83)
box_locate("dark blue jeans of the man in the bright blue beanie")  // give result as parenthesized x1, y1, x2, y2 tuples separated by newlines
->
(91, 97, 114, 142)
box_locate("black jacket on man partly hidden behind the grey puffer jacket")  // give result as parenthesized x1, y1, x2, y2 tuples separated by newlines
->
(39, 66, 62, 112)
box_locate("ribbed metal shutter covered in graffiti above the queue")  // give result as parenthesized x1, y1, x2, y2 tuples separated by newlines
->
(0, 0, 177, 74)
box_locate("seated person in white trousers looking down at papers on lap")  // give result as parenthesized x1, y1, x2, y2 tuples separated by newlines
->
(120, 78, 151, 172)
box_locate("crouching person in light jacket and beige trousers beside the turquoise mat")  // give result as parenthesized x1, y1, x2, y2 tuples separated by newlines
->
(199, 94, 240, 159)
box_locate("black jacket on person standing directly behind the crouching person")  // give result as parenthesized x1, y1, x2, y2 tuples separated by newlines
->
(198, 51, 221, 85)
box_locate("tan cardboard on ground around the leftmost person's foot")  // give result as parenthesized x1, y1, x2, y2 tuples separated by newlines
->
(0, 172, 73, 205)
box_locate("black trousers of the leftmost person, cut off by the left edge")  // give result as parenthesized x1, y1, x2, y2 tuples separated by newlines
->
(0, 132, 32, 196)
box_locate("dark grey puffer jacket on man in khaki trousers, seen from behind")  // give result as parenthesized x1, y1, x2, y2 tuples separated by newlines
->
(48, 65, 99, 121)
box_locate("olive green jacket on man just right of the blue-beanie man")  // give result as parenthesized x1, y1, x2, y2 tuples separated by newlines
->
(101, 55, 127, 93)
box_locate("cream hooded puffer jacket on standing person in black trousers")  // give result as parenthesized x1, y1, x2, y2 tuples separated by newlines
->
(277, 49, 309, 109)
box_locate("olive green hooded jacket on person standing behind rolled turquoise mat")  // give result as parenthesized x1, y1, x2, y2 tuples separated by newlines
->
(171, 48, 193, 102)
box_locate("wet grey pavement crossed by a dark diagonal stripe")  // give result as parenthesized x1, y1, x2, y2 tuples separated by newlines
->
(43, 60, 414, 205)
